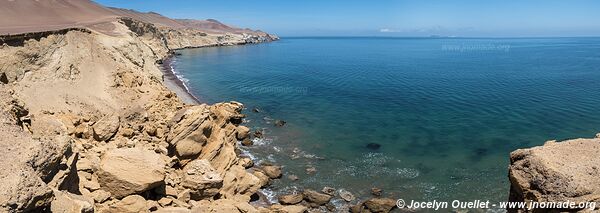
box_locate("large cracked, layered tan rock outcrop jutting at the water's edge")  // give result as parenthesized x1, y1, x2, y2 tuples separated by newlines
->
(166, 102, 243, 171)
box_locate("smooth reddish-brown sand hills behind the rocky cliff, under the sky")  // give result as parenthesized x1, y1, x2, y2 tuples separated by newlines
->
(0, 0, 259, 34)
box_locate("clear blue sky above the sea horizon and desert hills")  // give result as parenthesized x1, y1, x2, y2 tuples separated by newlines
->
(95, 0, 600, 37)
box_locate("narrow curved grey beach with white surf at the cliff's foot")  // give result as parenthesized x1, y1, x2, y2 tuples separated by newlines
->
(158, 54, 202, 105)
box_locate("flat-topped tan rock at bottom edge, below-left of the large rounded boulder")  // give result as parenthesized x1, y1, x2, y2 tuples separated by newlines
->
(50, 191, 94, 213)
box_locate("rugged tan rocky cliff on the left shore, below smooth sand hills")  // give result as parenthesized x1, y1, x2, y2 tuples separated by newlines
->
(0, 15, 282, 212)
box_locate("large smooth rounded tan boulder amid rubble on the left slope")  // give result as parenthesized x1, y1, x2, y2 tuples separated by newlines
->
(97, 148, 166, 198)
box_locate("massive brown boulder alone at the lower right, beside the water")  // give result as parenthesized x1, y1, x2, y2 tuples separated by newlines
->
(509, 138, 600, 211)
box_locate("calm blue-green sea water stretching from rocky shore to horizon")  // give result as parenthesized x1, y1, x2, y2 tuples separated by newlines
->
(174, 38, 600, 205)
